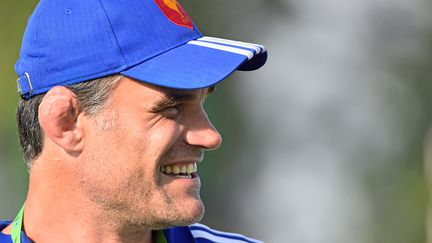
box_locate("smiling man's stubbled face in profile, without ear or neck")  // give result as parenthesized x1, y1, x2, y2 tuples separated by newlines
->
(77, 78, 221, 229)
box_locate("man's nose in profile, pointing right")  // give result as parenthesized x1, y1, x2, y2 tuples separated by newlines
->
(185, 110, 222, 150)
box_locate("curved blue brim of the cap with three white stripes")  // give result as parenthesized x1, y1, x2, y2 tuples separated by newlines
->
(121, 37, 267, 89)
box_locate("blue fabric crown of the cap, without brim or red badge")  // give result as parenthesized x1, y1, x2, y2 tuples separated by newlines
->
(15, 0, 202, 97)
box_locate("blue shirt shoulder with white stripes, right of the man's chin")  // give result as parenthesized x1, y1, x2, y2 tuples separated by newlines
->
(189, 224, 263, 243)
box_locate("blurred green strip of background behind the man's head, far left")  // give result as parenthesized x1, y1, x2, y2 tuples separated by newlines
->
(0, 0, 37, 218)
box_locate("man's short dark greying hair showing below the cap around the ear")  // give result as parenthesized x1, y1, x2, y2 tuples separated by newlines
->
(16, 74, 122, 169)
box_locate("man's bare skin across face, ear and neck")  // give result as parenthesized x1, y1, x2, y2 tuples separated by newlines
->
(3, 77, 222, 242)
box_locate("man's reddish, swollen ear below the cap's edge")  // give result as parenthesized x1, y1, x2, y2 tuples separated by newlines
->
(38, 86, 84, 153)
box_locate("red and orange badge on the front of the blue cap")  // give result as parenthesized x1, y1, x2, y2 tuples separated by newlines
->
(154, 0, 193, 29)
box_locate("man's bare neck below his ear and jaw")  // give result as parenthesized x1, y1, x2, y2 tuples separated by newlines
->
(15, 158, 152, 243)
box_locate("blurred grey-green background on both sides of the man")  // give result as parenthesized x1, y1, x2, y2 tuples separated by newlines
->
(0, 0, 432, 243)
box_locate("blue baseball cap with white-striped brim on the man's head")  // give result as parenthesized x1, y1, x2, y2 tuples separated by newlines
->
(15, 0, 267, 99)
